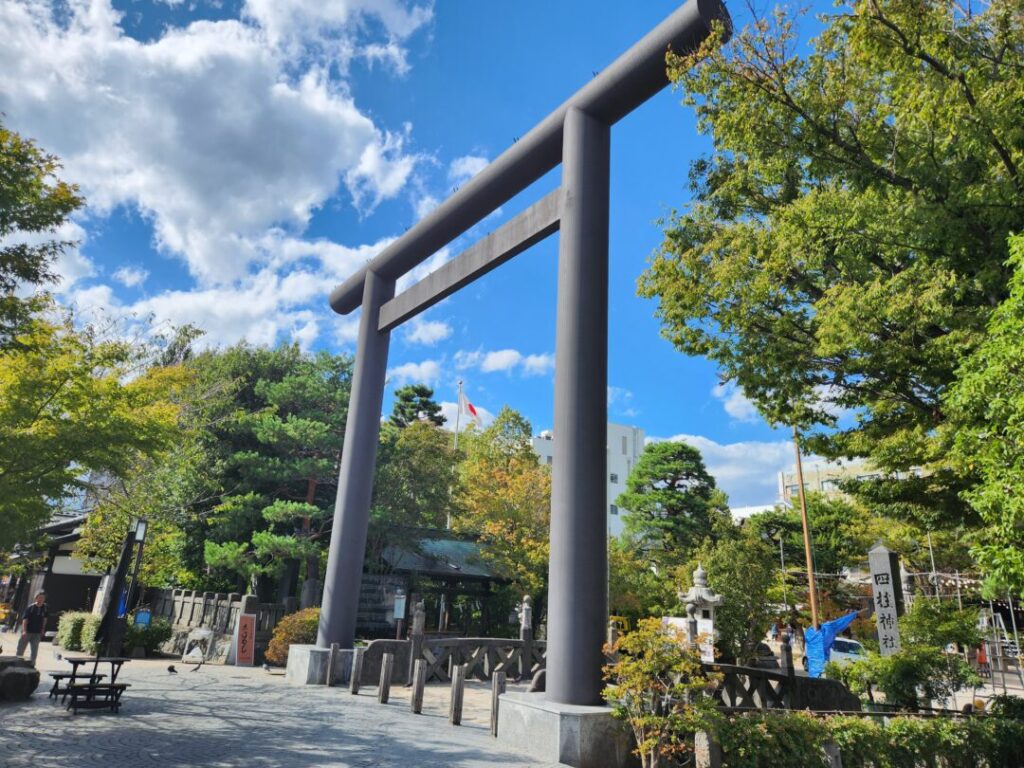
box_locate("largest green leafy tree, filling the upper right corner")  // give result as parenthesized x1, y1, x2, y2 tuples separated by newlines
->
(640, 0, 1024, 521)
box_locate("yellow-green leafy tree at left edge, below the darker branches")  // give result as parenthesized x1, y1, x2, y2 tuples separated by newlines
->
(0, 316, 186, 549)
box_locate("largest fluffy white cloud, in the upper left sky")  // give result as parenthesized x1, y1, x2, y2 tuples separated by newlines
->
(0, 0, 423, 288)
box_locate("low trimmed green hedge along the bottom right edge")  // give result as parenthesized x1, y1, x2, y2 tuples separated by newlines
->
(717, 712, 1024, 768)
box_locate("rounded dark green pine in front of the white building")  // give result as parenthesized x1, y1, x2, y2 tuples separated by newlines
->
(615, 441, 729, 568)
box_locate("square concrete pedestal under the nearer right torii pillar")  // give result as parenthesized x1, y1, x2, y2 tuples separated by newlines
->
(498, 693, 640, 768)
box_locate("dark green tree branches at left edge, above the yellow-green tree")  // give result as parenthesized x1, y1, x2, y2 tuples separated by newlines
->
(0, 121, 83, 348)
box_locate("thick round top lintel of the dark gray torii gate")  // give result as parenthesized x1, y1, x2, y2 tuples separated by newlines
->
(331, 0, 731, 314)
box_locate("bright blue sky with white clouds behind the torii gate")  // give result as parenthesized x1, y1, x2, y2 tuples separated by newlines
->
(0, 0, 819, 506)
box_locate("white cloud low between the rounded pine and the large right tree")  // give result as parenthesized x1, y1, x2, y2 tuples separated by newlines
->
(648, 434, 794, 507)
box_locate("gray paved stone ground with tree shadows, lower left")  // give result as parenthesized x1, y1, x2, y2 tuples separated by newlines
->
(0, 644, 555, 768)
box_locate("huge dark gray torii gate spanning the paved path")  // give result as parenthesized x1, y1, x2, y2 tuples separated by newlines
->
(316, 0, 730, 705)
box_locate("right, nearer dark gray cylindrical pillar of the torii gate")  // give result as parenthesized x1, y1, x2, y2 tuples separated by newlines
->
(545, 108, 611, 705)
